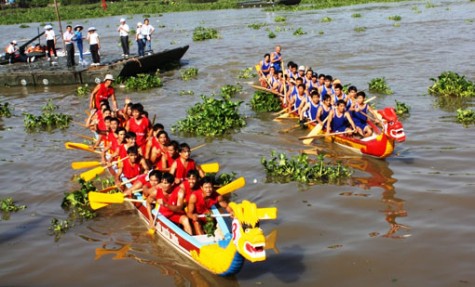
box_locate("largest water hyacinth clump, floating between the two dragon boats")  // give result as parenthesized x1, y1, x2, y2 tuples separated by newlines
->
(172, 88, 246, 137)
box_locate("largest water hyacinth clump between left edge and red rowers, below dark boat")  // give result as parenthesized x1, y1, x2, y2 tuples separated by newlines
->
(23, 99, 73, 132)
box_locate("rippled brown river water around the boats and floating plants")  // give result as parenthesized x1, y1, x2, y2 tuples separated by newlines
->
(0, 1, 475, 286)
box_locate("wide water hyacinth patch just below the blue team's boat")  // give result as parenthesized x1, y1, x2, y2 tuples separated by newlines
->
(261, 151, 352, 184)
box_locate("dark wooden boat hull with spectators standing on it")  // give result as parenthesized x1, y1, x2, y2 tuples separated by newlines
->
(0, 45, 189, 86)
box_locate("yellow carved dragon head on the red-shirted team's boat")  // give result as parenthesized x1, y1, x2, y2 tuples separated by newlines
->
(229, 200, 277, 262)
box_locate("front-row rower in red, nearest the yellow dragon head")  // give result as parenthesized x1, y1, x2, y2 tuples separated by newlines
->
(186, 176, 233, 235)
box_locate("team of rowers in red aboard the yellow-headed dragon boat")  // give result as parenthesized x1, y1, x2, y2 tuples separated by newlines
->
(86, 75, 232, 235)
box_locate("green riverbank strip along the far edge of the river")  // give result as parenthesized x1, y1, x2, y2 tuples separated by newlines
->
(0, 0, 410, 25)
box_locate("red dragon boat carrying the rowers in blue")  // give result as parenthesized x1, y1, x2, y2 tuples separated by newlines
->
(253, 86, 406, 159)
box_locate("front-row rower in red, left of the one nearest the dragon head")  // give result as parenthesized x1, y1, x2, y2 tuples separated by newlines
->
(147, 173, 192, 235)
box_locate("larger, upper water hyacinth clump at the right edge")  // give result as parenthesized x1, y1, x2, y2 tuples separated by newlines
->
(428, 71, 475, 98)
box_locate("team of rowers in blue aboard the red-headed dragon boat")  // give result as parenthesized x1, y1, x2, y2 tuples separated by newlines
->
(256, 46, 379, 137)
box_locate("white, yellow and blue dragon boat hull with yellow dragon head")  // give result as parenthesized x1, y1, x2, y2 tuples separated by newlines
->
(125, 190, 277, 276)
